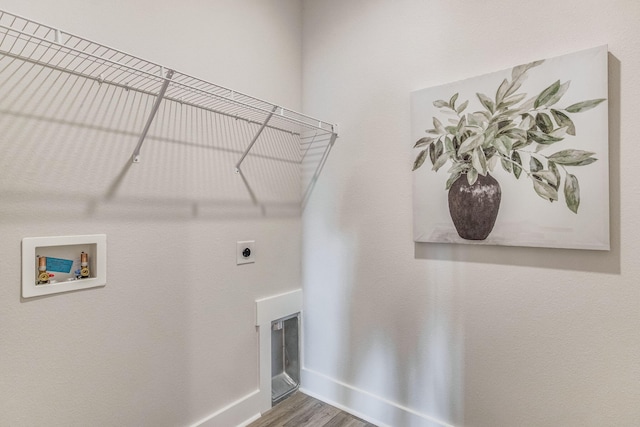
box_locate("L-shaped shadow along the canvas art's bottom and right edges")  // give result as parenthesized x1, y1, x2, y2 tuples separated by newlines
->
(415, 53, 621, 274)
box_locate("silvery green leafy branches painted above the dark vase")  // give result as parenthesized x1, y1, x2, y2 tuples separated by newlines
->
(413, 61, 605, 213)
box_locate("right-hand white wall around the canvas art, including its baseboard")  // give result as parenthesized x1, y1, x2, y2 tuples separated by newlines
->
(303, 0, 640, 427)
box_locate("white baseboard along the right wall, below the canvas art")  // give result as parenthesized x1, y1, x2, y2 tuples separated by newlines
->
(300, 368, 454, 427)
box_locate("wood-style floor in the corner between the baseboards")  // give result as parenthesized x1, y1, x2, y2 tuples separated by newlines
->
(247, 391, 376, 427)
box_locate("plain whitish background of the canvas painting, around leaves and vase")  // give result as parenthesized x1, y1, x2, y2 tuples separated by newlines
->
(411, 46, 609, 250)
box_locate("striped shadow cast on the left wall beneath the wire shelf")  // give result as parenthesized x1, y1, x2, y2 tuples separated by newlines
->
(0, 47, 329, 220)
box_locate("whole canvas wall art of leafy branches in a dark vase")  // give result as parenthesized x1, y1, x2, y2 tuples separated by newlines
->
(411, 46, 609, 250)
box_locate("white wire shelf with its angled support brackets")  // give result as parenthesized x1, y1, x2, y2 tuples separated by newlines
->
(0, 10, 337, 210)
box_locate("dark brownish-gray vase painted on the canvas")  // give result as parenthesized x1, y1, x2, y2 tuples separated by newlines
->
(449, 174, 502, 240)
